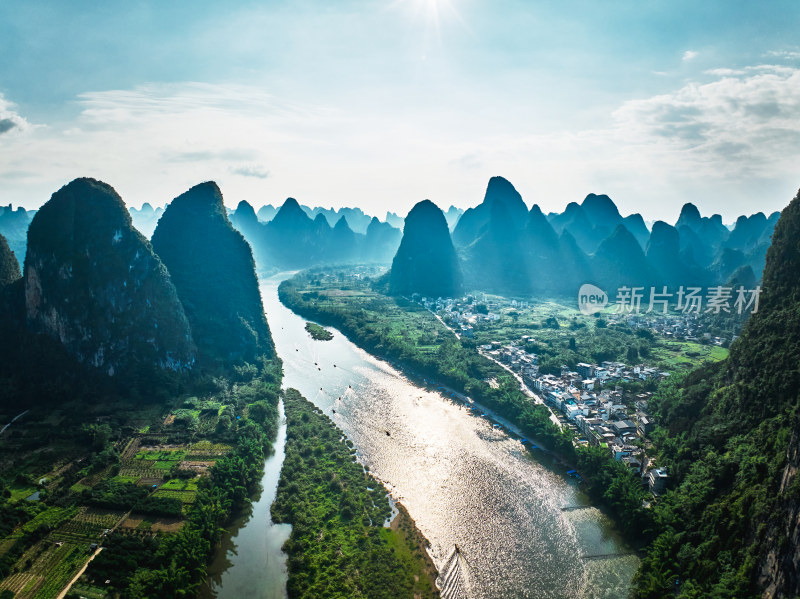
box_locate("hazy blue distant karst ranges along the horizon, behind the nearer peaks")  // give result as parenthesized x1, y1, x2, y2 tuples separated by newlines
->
(0, 177, 779, 294)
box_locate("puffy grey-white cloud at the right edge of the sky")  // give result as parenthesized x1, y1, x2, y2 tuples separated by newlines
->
(614, 65, 800, 177)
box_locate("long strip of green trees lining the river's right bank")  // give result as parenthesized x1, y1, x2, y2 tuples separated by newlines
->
(278, 273, 649, 539)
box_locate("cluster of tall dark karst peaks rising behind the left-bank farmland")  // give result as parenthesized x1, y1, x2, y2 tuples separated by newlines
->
(0, 178, 274, 405)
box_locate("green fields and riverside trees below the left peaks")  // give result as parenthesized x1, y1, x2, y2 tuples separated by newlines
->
(0, 360, 281, 597)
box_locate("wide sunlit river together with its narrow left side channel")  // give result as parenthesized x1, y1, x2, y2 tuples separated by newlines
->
(204, 275, 638, 599)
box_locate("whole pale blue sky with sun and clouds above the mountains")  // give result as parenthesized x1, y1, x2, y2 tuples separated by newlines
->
(0, 0, 800, 223)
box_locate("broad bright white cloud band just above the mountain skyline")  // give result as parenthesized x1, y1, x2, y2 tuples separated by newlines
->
(0, 65, 800, 221)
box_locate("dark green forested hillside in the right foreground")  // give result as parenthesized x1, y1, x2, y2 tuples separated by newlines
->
(637, 194, 800, 597)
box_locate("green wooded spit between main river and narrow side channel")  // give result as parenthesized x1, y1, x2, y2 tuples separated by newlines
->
(272, 389, 439, 599)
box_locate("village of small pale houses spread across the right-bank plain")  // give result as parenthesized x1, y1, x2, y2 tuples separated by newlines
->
(412, 294, 720, 496)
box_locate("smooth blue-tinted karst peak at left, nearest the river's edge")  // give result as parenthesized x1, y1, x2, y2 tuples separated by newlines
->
(153, 182, 274, 362)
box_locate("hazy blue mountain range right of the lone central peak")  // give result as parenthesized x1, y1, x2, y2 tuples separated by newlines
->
(440, 177, 779, 294)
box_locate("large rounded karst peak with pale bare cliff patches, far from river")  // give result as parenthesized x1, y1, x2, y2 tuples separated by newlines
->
(24, 179, 195, 374)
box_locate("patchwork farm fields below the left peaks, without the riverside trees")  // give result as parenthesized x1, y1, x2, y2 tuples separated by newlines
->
(0, 358, 280, 599)
